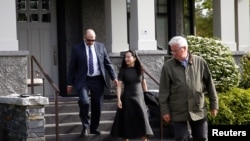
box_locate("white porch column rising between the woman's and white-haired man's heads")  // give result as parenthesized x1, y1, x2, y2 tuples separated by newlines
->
(130, 0, 157, 50)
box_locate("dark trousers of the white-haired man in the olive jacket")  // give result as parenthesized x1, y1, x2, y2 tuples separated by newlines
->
(173, 118, 208, 141)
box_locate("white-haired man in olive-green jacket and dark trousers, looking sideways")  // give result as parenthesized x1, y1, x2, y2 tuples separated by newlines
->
(159, 36, 218, 141)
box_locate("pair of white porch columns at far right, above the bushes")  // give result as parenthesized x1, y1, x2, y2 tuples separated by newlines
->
(213, 0, 250, 51)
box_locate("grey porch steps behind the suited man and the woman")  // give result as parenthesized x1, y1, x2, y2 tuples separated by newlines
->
(45, 97, 172, 141)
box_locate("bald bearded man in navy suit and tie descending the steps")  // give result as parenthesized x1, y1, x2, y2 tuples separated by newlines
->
(67, 29, 118, 136)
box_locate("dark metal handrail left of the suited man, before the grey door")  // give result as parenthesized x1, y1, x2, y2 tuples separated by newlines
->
(30, 55, 60, 141)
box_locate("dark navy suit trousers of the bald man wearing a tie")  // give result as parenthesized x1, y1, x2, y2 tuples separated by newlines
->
(78, 76, 104, 131)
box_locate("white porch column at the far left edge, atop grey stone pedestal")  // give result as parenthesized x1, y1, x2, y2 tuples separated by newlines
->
(0, 0, 18, 51)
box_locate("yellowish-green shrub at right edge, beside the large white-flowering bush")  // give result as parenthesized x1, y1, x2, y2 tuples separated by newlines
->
(239, 51, 250, 89)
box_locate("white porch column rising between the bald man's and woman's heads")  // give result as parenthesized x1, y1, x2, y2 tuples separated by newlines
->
(105, 0, 129, 53)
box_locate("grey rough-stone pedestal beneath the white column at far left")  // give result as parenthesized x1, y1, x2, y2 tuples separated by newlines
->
(0, 51, 28, 96)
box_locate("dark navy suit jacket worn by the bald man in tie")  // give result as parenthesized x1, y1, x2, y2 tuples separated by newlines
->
(67, 41, 116, 90)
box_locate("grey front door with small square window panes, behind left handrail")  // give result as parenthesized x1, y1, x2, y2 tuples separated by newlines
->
(16, 0, 58, 97)
